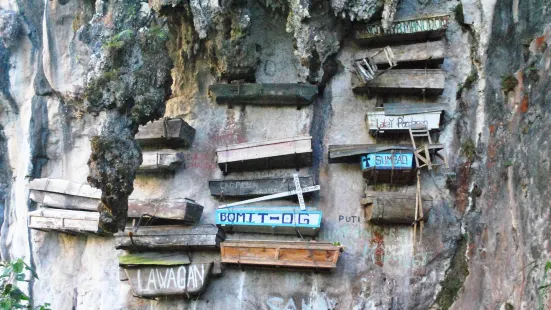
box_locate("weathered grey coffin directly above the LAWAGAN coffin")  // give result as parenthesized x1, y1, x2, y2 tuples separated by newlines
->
(115, 225, 226, 250)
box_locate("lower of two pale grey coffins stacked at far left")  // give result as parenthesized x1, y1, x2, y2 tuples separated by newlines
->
(29, 208, 104, 234)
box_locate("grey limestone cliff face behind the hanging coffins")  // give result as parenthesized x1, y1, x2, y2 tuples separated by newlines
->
(0, 0, 551, 310)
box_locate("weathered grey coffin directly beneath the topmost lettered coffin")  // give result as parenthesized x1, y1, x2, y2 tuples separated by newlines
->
(354, 40, 446, 65)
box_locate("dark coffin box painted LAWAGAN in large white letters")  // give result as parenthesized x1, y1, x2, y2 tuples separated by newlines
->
(125, 262, 213, 298)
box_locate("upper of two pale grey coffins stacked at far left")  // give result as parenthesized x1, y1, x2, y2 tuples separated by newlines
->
(29, 179, 101, 211)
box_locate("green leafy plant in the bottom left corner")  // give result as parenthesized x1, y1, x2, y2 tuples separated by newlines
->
(0, 258, 50, 310)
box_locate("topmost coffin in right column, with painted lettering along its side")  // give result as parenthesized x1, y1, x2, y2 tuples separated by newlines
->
(354, 15, 449, 46)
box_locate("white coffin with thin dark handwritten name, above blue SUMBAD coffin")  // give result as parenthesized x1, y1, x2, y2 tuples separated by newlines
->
(367, 105, 445, 133)
